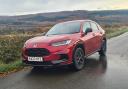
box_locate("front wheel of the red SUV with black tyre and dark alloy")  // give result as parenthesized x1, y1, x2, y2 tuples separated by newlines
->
(73, 48, 85, 71)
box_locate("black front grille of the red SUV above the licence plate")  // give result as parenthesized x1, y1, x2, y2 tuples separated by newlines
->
(25, 48, 50, 57)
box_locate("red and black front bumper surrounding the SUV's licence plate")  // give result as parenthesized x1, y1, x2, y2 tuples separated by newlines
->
(22, 48, 72, 66)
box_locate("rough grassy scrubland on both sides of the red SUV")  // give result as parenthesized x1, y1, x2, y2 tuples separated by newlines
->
(0, 26, 128, 74)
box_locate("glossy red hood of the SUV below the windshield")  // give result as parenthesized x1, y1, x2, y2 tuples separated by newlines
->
(26, 33, 80, 45)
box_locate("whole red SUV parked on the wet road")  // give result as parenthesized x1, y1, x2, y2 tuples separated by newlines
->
(22, 20, 107, 70)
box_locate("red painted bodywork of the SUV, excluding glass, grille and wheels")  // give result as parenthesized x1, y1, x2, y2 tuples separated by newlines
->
(22, 20, 105, 66)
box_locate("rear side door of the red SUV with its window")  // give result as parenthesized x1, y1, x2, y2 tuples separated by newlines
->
(91, 22, 102, 51)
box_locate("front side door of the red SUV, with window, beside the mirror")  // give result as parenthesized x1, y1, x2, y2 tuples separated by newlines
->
(82, 21, 95, 55)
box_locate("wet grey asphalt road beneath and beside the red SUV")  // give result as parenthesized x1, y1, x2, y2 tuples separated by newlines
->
(0, 33, 128, 89)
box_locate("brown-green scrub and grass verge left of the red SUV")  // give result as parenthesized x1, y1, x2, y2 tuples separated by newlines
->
(0, 34, 33, 76)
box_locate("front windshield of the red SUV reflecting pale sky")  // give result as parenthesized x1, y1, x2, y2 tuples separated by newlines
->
(46, 22, 80, 35)
